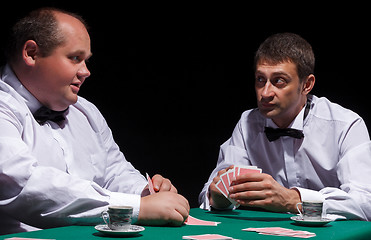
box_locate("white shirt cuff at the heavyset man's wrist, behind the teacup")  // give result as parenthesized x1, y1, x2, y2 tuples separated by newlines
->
(109, 192, 141, 223)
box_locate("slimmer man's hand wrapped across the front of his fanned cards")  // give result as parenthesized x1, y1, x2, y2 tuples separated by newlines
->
(229, 173, 301, 213)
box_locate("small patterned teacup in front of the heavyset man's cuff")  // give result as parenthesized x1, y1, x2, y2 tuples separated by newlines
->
(102, 206, 133, 231)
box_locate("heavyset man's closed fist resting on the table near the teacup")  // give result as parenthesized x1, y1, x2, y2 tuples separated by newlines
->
(138, 191, 190, 226)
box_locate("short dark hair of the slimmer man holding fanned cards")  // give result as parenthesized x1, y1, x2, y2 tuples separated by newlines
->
(254, 33, 315, 81)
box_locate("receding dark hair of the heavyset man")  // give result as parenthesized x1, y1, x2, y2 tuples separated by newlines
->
(5, 8, 87, 62)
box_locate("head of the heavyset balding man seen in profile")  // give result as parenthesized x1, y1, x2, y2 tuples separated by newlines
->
(9, 9, 92, 111)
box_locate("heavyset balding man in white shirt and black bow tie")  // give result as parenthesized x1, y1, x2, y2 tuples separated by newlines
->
(0, 9, 189, 234)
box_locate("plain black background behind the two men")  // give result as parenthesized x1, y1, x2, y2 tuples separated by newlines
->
(0, 1, 371, 207)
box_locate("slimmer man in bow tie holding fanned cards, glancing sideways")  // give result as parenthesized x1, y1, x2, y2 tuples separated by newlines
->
(200, 33, 371, 220)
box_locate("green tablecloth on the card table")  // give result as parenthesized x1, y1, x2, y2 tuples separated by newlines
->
(0, 208, 371, 240)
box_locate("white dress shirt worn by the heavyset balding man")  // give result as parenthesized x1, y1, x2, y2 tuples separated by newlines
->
(0, 65, 147, 234)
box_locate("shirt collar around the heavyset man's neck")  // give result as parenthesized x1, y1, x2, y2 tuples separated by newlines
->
(2, 64, 42, 113)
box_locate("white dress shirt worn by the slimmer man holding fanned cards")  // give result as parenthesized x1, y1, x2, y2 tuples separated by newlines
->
(199, 96, 371, 220)
